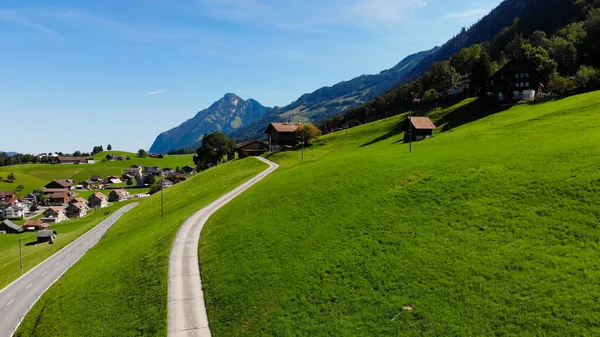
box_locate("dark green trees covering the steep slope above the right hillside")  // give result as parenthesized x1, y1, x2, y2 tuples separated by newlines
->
(320, 0, 600, 130)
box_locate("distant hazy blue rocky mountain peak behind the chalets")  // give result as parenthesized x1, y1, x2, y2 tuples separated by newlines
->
(150, 93, 271, 153)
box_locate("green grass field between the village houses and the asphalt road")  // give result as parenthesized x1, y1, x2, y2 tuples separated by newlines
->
(0, 200, 138, 289)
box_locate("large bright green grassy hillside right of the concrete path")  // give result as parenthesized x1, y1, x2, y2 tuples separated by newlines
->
(199, 92, 600, 337)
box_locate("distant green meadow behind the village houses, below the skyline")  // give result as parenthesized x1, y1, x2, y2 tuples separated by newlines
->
(0, 151, 195, 194)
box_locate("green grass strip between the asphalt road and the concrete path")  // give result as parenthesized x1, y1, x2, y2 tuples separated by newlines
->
(16, 158, 267, 337)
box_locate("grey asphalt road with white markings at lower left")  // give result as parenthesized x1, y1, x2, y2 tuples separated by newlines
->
(0, 203, 137, 337)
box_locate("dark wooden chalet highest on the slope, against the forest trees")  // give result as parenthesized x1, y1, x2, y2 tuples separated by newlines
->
(492, 60, 544, 101)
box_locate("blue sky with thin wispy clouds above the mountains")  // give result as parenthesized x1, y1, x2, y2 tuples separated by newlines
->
(0, 0, 501, 153)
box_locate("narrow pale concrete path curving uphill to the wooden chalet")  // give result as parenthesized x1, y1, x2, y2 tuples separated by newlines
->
(168, 157, 279, 337)
